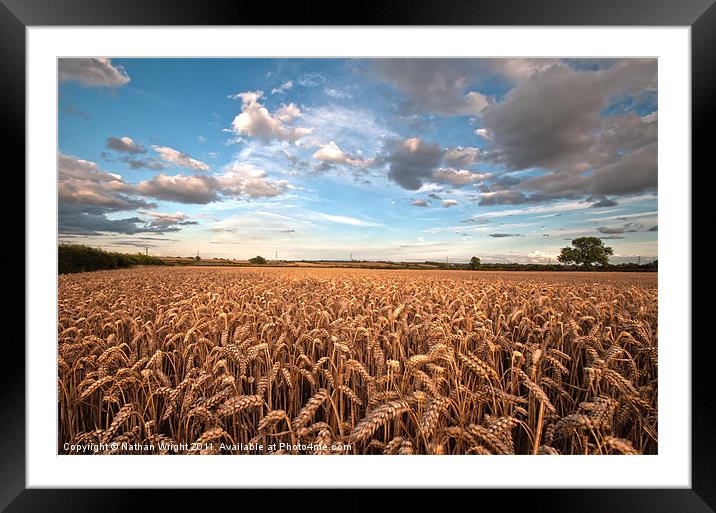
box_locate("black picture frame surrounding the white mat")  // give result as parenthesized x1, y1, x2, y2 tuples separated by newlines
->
(0, 0, 716, 513)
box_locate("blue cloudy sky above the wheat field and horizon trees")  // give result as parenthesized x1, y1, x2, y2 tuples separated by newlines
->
(58, 58, 658, 262)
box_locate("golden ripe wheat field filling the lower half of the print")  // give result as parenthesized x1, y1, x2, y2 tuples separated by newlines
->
(58, 267, 658, 455)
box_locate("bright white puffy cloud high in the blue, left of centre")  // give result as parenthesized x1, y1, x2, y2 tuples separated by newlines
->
(231, 91, 311, 142)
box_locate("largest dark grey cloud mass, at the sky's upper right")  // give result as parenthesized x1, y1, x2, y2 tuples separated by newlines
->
(482, 59, 657, 198)
